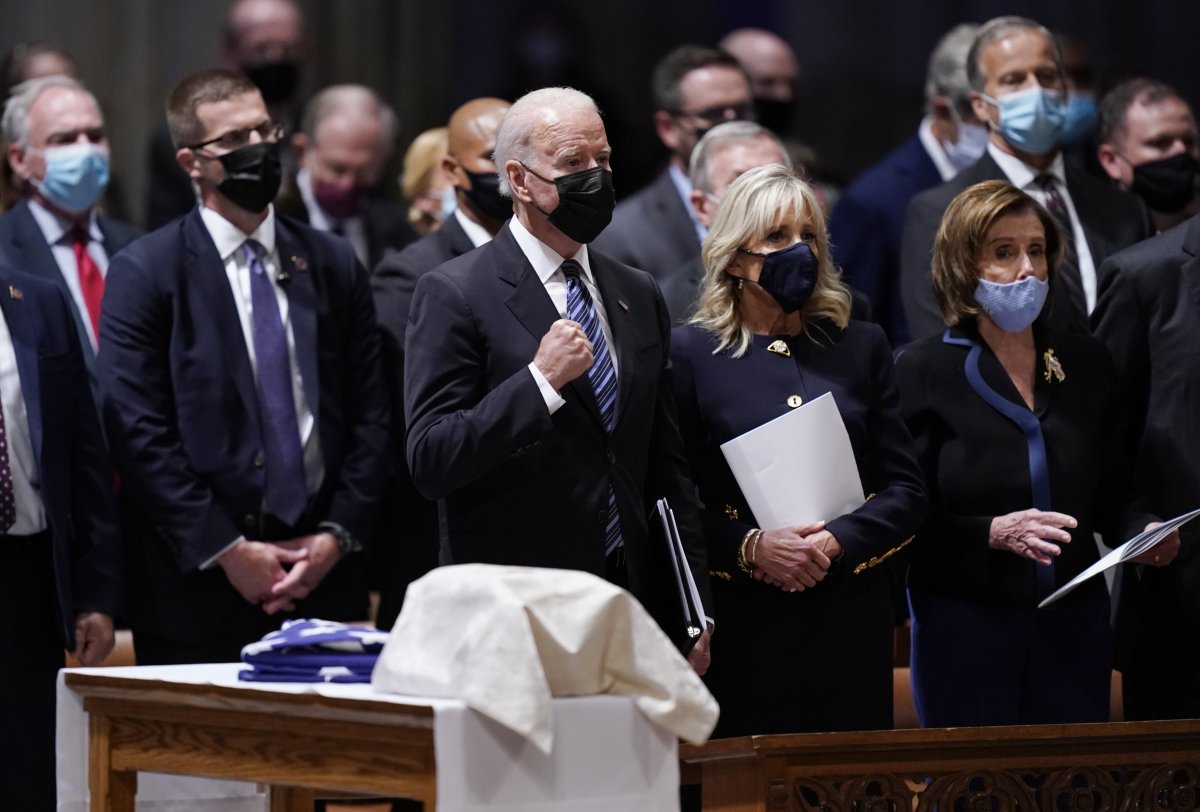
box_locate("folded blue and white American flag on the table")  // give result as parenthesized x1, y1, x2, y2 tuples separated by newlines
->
(238, 620, 388, 682)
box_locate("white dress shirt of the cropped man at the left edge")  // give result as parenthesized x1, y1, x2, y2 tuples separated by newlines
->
(0, 301, 45, 536)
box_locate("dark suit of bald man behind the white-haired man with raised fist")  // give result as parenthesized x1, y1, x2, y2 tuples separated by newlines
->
(371, 216, 475, 628)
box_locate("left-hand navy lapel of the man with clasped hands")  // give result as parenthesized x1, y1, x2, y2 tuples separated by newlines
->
(184, 209, 260, 429)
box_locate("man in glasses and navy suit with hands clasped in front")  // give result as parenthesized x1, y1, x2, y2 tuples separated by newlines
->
(97, 70, 388, 662)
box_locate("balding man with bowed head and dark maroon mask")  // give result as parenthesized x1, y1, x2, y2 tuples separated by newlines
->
(275, 84, 416, 267)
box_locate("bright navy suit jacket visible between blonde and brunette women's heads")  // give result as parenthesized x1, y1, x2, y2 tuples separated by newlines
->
(829, 136, 942, 347)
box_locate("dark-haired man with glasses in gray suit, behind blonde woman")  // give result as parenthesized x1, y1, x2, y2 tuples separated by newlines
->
(596, 46, 755, 284)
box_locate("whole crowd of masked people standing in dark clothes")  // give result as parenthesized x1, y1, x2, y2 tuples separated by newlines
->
(0, 0, 1200, 808)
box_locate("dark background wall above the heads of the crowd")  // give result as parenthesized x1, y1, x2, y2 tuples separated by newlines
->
(0, 0, 1200, 227)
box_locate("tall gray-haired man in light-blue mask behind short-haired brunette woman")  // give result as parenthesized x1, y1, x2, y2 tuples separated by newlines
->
(900, 17, 1153, 338)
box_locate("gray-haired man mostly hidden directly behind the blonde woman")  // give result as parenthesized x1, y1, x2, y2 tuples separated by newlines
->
(662, 121, 792, 323)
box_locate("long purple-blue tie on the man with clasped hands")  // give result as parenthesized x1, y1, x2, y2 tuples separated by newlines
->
(241, 240, 308, 524)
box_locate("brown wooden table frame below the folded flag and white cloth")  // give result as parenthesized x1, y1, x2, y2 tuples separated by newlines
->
(65, 673, 437, 812)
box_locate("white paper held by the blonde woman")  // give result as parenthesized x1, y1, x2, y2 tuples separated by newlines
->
(721, 392, 866, 529)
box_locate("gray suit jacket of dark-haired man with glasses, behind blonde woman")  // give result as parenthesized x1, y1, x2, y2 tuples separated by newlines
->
(592, 170, 700, 285)
